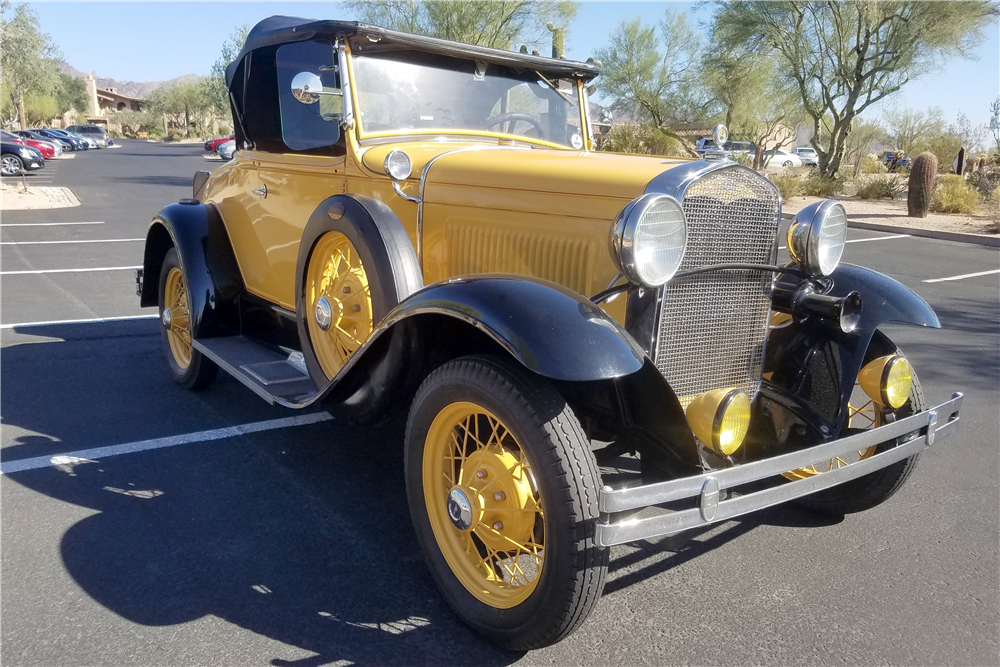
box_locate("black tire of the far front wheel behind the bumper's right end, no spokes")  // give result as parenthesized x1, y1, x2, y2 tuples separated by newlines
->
(798, 331, 927, 516)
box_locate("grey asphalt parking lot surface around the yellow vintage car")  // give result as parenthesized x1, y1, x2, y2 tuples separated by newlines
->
(0, 141, 1000, 667)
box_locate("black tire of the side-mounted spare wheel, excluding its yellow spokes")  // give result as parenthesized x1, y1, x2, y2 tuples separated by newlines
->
(295, 195, 423, 390)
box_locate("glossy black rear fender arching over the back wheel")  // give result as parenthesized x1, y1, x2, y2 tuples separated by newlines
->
(139, 203, 243, 338)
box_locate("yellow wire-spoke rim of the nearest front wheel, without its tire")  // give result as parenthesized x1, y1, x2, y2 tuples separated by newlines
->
(422, 402, 545, 609)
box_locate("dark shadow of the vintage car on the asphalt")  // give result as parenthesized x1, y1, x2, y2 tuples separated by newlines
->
(2, 321, 844, 666)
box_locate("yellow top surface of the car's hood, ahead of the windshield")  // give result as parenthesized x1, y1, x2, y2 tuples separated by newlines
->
(363, 142, 688, 217)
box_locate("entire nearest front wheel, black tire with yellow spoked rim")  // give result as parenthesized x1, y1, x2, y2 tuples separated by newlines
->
(406, 357, 608, 650)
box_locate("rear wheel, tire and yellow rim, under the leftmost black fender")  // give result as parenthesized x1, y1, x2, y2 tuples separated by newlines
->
(160, 248, 219, 389)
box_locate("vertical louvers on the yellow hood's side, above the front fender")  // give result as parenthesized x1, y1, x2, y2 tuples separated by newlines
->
(445, 223, 597, 294)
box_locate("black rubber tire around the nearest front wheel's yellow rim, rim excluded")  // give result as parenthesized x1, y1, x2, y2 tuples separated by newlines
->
(405, 357, 608, 650)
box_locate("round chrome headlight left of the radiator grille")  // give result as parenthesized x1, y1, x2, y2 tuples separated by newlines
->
(608, 193, 687, 287)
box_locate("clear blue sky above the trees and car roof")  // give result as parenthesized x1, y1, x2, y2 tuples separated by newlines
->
(21, 1, 1000, 129)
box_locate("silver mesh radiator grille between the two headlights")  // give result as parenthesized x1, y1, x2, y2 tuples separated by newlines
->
(656, 168, 779, 407)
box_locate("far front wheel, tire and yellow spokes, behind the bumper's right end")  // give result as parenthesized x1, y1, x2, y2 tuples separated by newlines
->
(785, 331, 926, 515)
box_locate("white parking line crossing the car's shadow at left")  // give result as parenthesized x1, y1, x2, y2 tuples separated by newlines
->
(0, 412, 333, 475)
